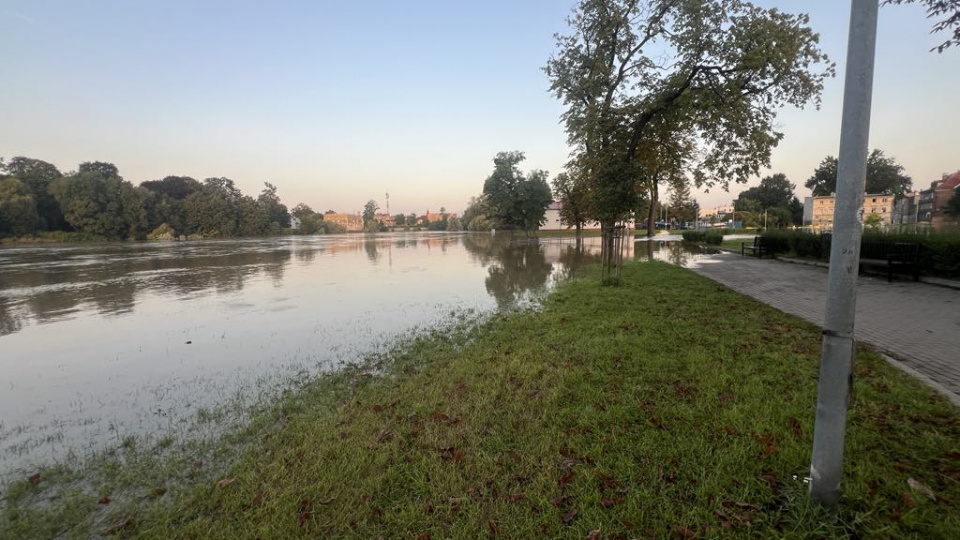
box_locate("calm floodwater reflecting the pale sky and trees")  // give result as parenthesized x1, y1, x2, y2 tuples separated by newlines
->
(0, 233, 716, 478)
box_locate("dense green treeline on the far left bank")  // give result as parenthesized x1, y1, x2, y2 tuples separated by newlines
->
(0, 157, 338, 240)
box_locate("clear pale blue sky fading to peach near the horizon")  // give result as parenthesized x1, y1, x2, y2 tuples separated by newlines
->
(0, 0, 960, 213)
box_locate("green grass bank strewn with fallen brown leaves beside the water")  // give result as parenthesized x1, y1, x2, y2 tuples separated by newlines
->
(0, 262, 960, 539)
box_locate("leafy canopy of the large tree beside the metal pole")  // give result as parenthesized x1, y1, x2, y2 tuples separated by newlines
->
(545, 0, 834, 230)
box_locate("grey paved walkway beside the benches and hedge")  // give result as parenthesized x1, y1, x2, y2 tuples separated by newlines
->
(688, 253, 960, 403)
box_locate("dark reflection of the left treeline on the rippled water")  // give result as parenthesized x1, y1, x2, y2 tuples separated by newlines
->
(0, 243, 291, 335)
